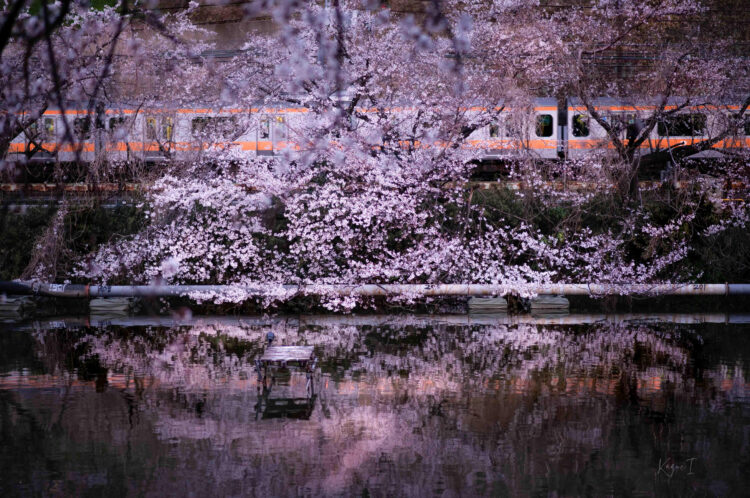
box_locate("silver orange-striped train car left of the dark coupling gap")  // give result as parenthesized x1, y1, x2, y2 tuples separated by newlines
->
(4, 99, 559, 162)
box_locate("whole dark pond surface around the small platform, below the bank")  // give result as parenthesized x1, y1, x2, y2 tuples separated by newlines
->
(0, 316, 750, 496)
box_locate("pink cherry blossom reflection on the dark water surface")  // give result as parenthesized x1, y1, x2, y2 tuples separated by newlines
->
(2, 319, 747, 495)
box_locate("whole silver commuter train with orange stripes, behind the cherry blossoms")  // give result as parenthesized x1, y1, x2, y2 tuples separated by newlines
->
(8, 98, 750, 163)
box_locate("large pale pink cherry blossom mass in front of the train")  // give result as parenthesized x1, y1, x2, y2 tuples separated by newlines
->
(1, 0, 747, 308)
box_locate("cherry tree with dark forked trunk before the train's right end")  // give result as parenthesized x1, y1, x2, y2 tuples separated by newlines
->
(543, 0, 750, 197)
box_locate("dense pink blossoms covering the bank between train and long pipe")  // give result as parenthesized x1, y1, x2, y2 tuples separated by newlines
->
(51, 157, 748, 308)
